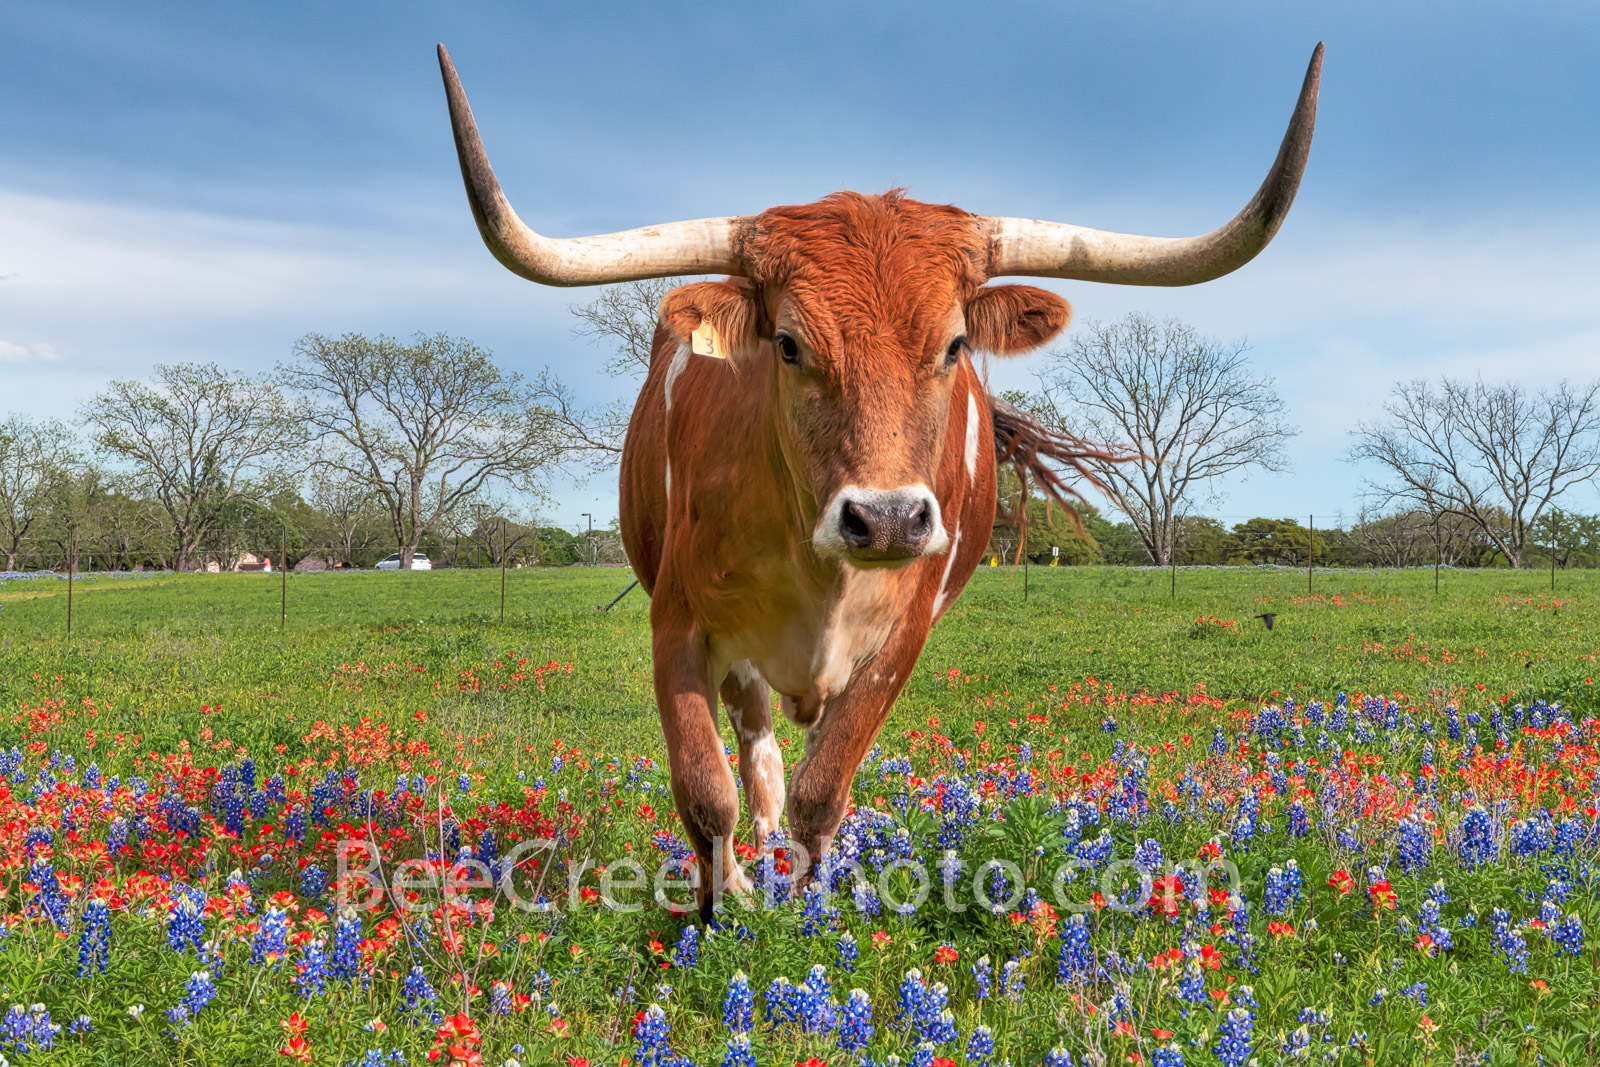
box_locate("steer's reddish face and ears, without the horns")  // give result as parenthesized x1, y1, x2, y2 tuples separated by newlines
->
(662, 194, 1067, 566)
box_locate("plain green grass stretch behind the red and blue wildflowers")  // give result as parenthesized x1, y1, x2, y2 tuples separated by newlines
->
(0, 568, 1600, 753)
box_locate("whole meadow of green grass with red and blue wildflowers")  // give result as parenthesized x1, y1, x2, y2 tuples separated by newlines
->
(0, 568, 1600, 1067)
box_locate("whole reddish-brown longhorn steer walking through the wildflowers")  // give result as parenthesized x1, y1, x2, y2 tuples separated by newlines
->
(438, 45, 1322, 918)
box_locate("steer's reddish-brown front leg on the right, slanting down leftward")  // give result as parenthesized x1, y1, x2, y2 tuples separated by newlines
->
(789, 617, 931, 891)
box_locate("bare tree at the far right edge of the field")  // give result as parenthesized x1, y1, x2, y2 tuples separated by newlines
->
(1350, 378, 1600, 566)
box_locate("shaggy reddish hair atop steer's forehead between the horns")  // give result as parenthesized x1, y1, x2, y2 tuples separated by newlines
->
(744, 189, 987, 358)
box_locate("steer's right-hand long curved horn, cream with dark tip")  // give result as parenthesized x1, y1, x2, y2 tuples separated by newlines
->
(989, 43, 1322, 285)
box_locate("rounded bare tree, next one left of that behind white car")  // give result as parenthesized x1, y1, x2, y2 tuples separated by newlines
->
(83, 363, 304, 569)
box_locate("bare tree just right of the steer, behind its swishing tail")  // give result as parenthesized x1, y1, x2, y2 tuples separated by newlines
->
(1029, 314, 1298, 565)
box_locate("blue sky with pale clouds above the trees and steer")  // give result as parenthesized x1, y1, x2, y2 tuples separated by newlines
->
(0, 2, 1600, 523)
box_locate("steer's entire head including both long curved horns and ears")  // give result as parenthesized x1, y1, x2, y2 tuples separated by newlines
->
(438, 45, 1322, 566)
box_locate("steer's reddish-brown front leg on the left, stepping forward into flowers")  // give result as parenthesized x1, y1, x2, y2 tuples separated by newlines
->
(650, 598, 739, 923)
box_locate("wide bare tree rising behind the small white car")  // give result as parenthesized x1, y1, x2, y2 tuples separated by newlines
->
(278, 333, 566, 569)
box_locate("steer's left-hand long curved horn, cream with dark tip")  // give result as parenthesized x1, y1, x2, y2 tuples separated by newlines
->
(438, 45, 749, 285)
